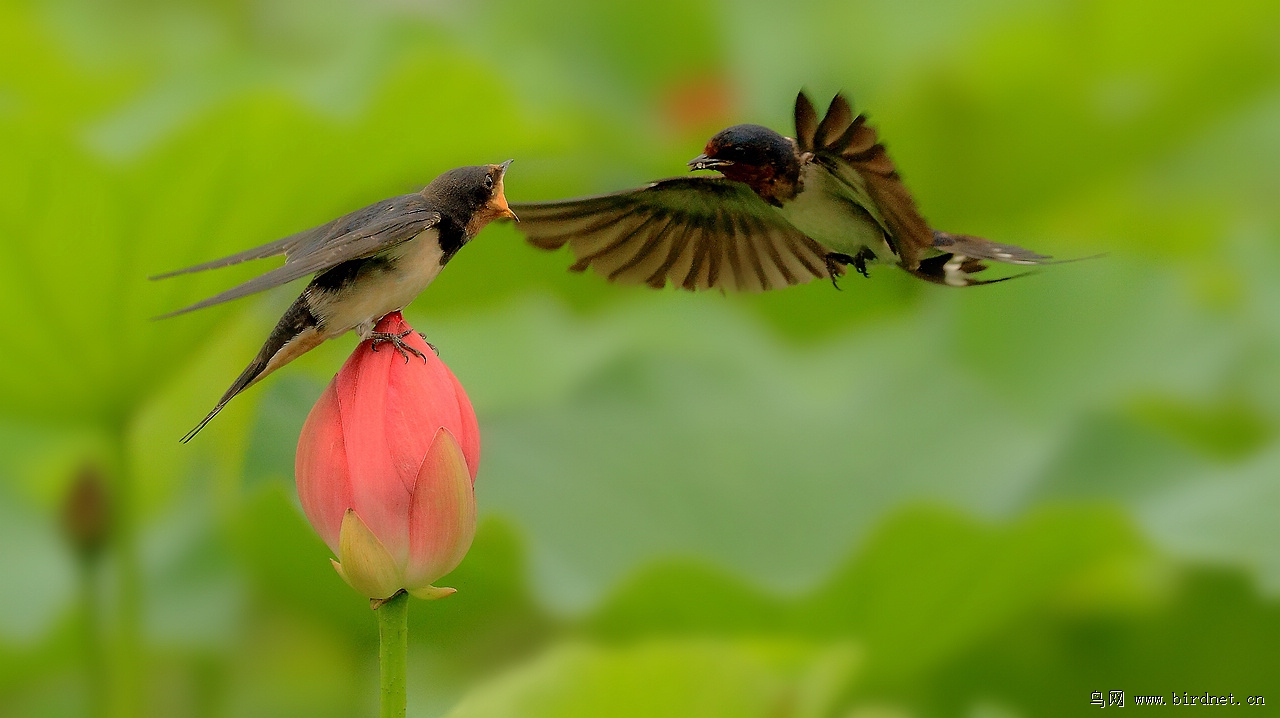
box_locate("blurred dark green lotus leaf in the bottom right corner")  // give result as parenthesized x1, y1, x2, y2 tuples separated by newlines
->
(911, 570, 1280, 718)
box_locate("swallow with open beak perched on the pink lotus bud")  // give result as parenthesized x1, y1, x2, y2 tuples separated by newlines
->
(151, 160, 516, 443)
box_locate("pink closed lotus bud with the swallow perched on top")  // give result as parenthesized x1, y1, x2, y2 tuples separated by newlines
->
(296, 312, 480, 599)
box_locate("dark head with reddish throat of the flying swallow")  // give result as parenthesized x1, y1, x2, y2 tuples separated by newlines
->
(689, 124, 800, 203)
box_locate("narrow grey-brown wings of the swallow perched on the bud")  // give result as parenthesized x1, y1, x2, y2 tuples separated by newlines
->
(152, 193, 440, 319)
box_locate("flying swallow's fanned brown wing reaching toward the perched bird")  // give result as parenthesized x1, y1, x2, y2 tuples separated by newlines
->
(511, 177, 829, 292)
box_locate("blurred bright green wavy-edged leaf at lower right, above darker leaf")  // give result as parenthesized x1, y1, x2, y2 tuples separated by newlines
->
(590, 509, 1158, 681)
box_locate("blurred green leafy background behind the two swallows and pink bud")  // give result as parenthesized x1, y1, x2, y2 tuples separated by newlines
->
(0, 0, 1280, 718)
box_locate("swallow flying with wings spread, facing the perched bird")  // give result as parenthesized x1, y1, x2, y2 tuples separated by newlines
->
(512, 92, 1051, 292)
